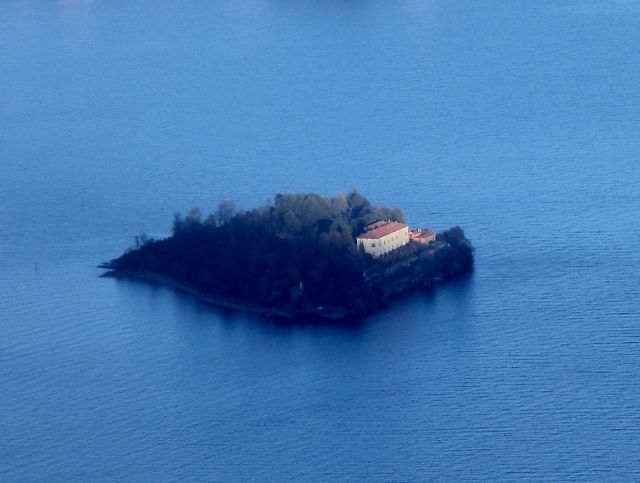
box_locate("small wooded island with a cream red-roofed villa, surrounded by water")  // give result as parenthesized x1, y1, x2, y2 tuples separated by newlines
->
(101, 190, 474, 319)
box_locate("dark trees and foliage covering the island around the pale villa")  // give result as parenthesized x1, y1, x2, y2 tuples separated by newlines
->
(111, 191, 473, 312)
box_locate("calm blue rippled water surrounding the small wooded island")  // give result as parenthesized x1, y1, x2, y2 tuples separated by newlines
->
(0, 0, 640, 482)
